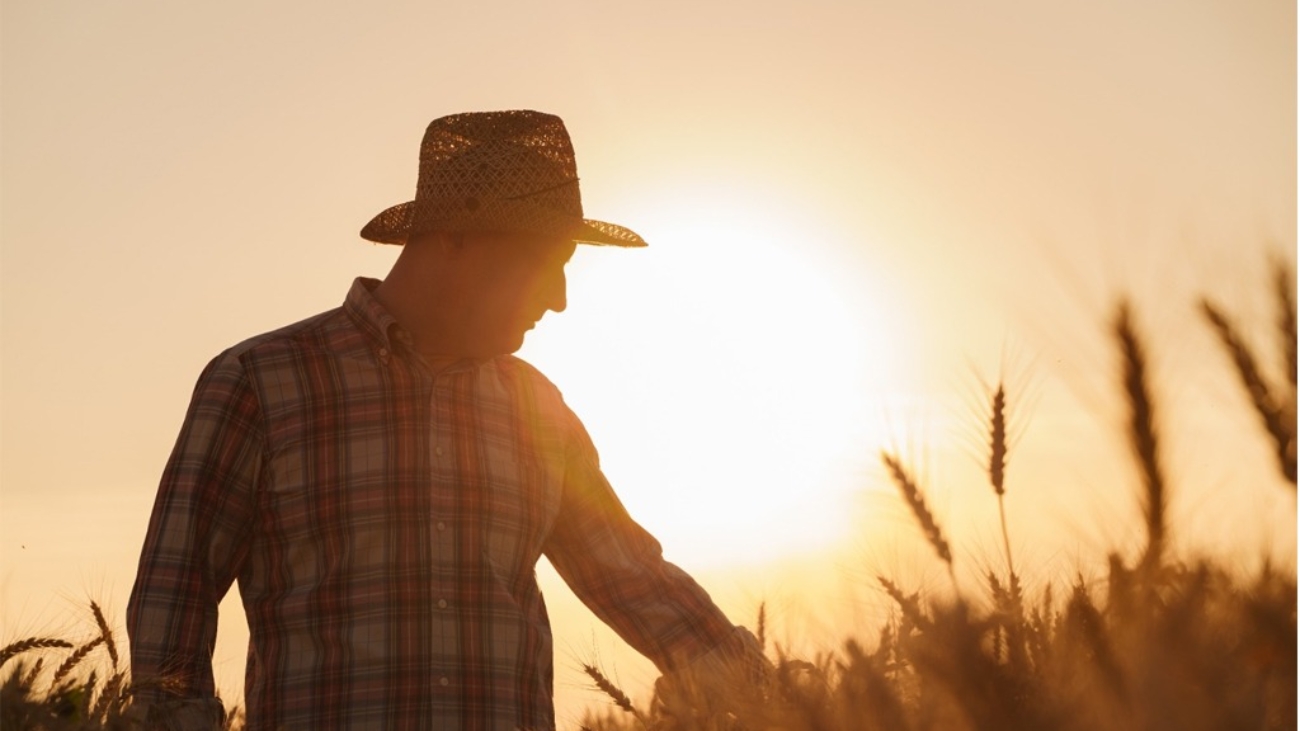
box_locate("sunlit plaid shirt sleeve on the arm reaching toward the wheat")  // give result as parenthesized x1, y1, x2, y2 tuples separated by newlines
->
(546, 416, 736, 674)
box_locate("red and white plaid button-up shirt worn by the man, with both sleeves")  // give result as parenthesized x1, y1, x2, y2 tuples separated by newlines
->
(127, 280, 735, 730)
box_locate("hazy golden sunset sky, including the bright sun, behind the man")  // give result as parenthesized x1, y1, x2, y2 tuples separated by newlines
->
(0, 0, 1296, 723)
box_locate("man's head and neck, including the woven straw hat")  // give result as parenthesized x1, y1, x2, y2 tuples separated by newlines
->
(361, 111, 646, 356)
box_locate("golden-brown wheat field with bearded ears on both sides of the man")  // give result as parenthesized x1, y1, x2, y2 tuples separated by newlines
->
(0, 258, 1296, 731)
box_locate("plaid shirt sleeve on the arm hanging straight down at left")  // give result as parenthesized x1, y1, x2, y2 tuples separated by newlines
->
(127, 352, 264, 718)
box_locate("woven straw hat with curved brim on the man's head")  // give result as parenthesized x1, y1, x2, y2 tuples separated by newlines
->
(361, 111, 646, 246)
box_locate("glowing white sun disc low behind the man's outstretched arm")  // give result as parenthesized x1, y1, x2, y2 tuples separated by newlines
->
(520, 180, 900, 565)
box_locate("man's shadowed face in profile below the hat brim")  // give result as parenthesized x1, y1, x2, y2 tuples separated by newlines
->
(464, 234, 576, 355)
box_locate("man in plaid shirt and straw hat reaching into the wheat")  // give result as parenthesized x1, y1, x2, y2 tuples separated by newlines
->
(127, 112, 754, 730)
